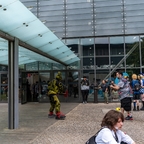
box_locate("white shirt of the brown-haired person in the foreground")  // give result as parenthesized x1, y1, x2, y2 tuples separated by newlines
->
(95, 128, 134, 144)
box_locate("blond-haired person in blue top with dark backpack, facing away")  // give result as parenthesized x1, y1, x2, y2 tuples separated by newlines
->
(130, 74, 140, 111)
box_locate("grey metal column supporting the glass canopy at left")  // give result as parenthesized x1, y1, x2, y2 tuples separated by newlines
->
(8, 38, 19, 129)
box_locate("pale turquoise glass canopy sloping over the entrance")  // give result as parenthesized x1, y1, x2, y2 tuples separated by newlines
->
(0, 0, 80, 65)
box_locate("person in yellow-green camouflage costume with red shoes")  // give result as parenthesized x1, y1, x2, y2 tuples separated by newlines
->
(48, 72, 66, 119)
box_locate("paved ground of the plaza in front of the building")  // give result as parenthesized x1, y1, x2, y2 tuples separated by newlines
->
(0, 103, 144, 144)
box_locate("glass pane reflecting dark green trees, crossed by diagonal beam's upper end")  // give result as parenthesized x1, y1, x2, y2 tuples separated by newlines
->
(125, 36, 140, 68)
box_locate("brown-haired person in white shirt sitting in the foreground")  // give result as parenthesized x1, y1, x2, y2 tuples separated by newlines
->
(95, 110, 136, 144)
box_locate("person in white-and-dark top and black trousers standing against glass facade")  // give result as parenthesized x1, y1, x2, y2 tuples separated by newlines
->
(81, 76, 89, 103)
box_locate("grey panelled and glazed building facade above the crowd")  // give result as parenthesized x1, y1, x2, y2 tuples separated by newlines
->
(18, 0, 144, 100)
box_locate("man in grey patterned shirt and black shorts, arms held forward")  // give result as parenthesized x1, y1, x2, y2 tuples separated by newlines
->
(110, 72, 133, 120)
